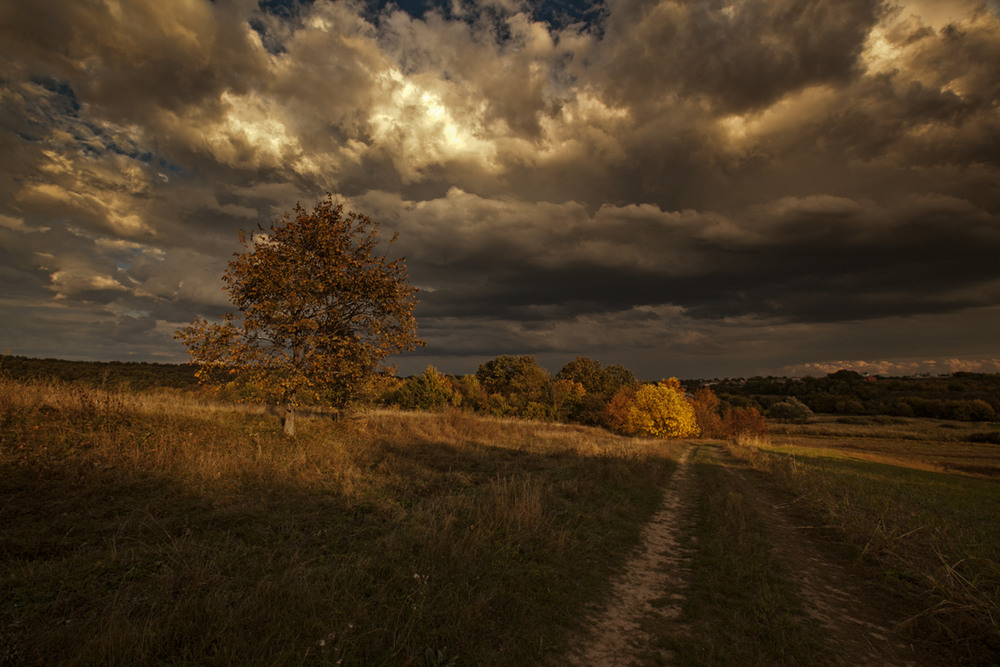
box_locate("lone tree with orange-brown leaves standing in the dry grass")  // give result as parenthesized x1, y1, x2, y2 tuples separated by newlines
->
(176, 196, 423, 435)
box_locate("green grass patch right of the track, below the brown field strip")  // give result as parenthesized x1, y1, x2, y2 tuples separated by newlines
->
(761, 446, 1000, 659)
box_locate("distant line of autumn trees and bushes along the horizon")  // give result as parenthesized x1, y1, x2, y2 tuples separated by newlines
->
(0, 355, 1000, 438)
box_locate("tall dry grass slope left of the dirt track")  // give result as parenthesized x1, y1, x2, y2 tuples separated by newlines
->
(0, 379, 675, 665)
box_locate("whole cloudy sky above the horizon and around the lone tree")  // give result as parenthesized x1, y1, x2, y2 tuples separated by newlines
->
(0, 0, 1000, 379)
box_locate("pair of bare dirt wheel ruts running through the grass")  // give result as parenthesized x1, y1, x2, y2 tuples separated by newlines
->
(566, 445, 937, 667)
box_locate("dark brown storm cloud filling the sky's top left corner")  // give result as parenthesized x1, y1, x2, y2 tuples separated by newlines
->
(0, 0, 265, 119)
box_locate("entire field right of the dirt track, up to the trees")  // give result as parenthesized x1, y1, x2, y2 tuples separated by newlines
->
(743, 418, 1000, 656)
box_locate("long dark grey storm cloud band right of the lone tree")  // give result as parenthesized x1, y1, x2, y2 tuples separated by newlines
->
(366, 191, 1000, 332)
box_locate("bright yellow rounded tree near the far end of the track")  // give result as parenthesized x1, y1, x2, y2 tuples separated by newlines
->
(624, 378, 699, 438)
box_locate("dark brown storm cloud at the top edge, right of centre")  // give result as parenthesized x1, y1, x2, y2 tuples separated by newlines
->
(597, 0, 882, 113)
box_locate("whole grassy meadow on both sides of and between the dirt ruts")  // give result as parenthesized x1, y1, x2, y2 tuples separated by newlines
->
(0, 378, 1000, 665)
